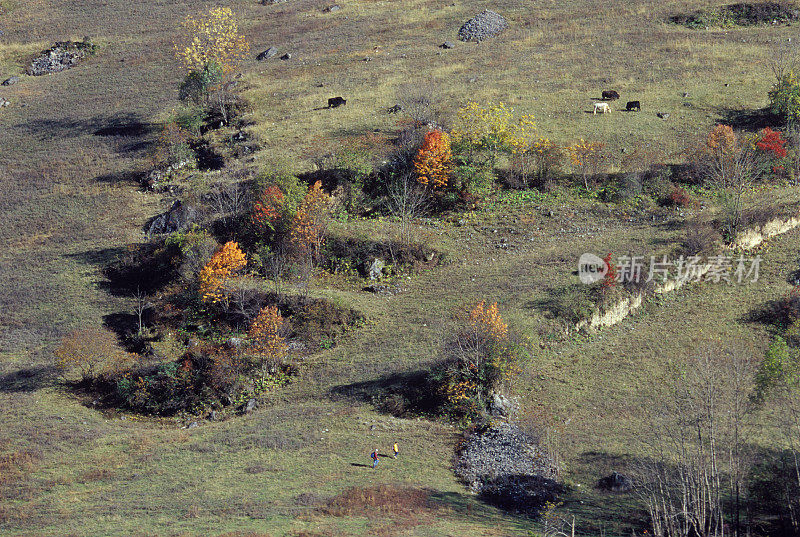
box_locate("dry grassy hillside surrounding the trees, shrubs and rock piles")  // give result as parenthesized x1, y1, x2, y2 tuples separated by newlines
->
(0, 0, 800, 536)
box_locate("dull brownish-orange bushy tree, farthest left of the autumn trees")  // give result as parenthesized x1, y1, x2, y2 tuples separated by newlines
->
(53, 328, 135, 382)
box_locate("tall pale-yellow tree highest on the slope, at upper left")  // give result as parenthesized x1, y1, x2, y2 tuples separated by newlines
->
(175, 7, 250, 123)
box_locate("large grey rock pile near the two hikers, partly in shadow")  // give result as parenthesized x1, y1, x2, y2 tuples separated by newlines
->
(455, 423, 562, 511)
